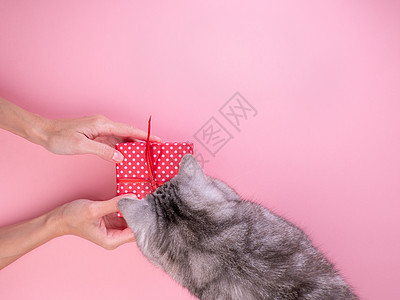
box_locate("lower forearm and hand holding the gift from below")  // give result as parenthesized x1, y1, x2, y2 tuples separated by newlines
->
(0, 195, 135, 270)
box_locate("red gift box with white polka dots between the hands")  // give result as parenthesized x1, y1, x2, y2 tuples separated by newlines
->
(115, 142, 193, 199)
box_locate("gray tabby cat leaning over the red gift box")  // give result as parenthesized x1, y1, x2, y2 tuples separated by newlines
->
(118, 154, 358, 300)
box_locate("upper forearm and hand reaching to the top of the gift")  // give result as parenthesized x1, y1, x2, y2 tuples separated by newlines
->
(0, 98, 155, 163)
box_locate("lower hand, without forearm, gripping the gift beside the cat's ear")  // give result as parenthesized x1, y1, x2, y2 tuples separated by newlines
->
(55, 195, 135, 249)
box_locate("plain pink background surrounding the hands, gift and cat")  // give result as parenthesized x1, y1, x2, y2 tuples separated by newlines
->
(0, 0, 400, 300)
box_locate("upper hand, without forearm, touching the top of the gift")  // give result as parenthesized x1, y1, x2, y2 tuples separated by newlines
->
(41, 115, 161, 163)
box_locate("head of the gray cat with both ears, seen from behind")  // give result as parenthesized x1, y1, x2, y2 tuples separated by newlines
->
(118, 154, 240, 263)
